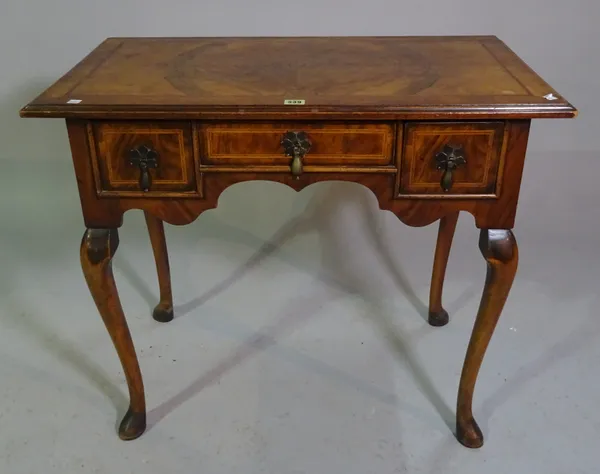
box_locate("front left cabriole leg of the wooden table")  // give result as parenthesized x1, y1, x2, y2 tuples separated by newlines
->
(81, 229, 146, 440)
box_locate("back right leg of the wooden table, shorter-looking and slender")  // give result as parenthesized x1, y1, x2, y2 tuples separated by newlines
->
(428, 212, 459, 326)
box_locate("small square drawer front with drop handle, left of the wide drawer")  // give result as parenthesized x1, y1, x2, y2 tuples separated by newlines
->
(92, 122, 197, 196)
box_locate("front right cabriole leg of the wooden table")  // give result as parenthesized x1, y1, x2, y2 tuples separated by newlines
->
(456, 229, 519, 448)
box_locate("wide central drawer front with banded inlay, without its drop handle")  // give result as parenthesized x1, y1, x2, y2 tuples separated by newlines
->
(200, 122, 395, 166)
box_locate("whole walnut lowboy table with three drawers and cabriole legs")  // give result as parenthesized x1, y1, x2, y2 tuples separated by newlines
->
(21, 36, 577, 448)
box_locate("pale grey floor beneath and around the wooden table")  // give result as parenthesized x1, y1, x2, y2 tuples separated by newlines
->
(0, 150, 600, 474)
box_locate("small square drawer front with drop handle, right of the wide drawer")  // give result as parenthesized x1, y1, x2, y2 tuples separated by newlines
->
(399, 122, 505, 197)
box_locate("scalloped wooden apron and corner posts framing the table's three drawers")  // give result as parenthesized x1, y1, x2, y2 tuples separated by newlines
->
(68, 120, 529, 229)
